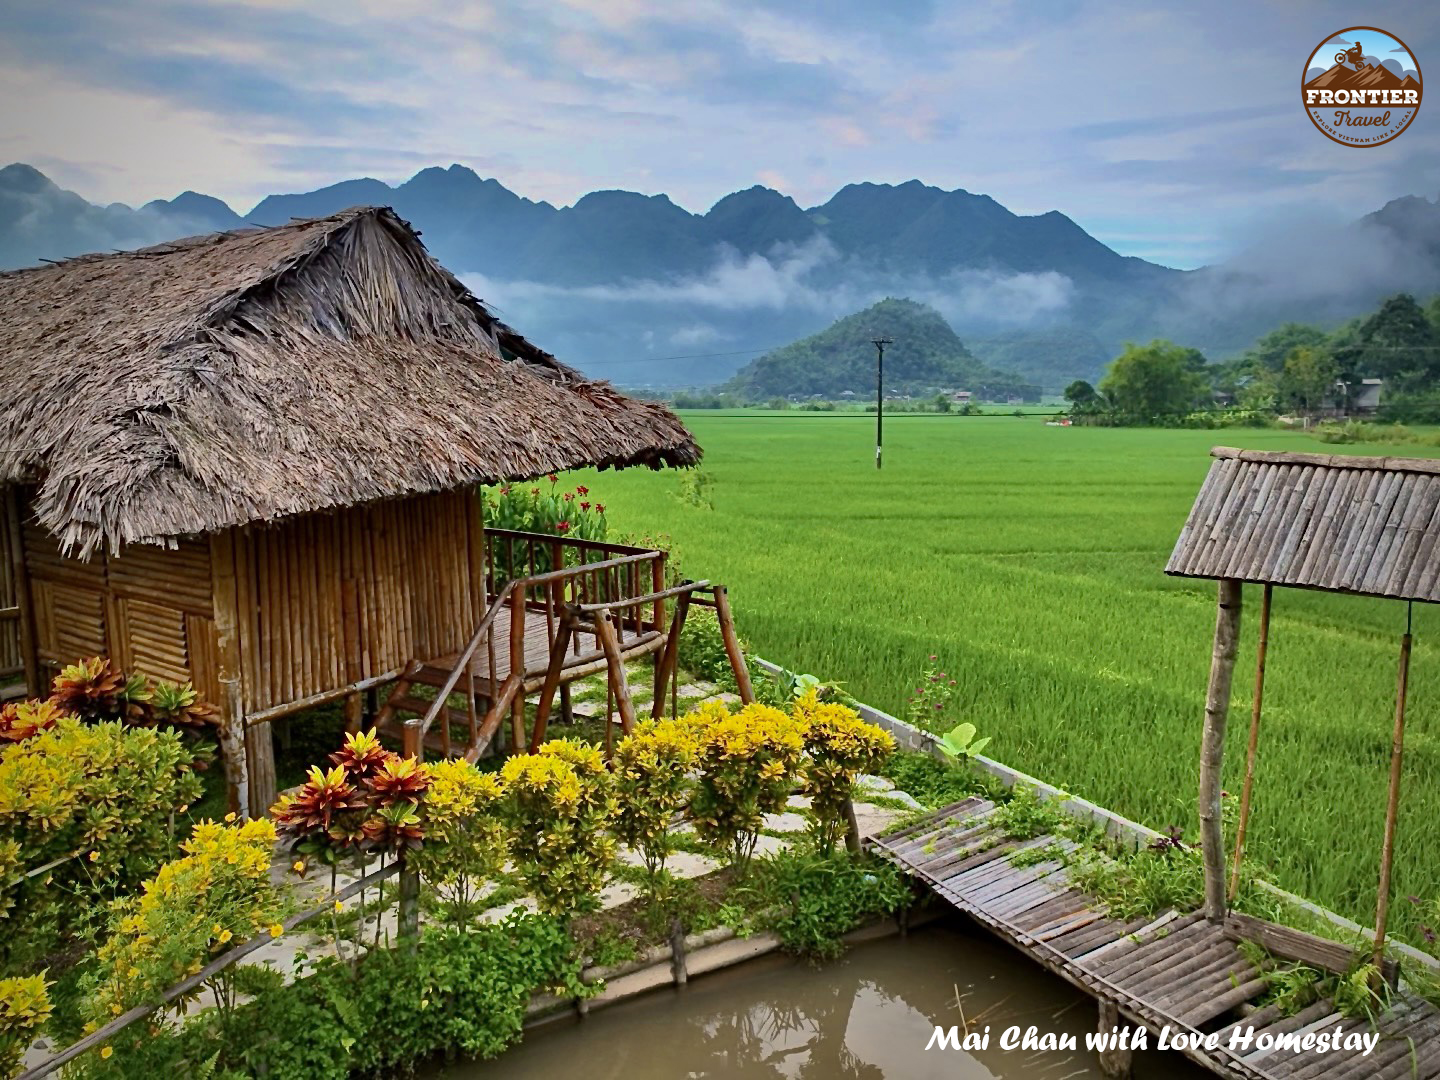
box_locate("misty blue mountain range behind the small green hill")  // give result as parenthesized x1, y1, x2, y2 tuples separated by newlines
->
(0, 164, 1440, 390)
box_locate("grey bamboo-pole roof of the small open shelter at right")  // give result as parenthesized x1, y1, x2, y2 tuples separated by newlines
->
(1165, 446, 1440, 602)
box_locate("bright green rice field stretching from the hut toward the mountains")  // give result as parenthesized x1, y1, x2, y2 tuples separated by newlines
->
(586, 412, 1440, 937)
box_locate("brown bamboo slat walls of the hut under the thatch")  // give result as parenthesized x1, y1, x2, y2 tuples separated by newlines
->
(16, 491, 484, 714)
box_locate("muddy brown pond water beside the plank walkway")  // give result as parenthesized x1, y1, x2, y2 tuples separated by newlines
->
(433, 923, 1210, 1080)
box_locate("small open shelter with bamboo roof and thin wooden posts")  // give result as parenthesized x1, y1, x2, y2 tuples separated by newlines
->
(1165, 446, 1440, 966)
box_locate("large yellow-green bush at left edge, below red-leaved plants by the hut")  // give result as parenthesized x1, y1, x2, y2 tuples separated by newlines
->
(0, 719, 200, 971)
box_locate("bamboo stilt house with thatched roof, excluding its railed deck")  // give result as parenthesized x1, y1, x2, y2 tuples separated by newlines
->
(0, 207, 700, 811)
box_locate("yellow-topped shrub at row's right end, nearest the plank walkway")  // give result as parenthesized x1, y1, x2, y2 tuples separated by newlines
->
(791, 690, 896, 854)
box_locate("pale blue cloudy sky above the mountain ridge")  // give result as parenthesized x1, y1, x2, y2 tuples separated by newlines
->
(0, 0, 1440, 266)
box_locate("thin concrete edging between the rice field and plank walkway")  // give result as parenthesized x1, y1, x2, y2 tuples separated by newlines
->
(750, 657, 1440, 971)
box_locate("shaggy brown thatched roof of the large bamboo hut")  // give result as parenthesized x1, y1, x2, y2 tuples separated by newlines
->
(0, 207, 700, 554)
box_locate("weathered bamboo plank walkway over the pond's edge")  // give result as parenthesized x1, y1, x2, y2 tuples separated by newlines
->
(871, 798, 1440, 1080)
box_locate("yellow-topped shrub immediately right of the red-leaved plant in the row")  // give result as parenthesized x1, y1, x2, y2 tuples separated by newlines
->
(409, 759, 508, 923)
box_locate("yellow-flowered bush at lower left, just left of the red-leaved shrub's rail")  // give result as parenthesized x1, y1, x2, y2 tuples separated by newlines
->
(85, 819, 285, 1030)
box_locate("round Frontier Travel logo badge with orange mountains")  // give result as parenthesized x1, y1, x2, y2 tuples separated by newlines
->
(1300, 26, 1420, 147)
